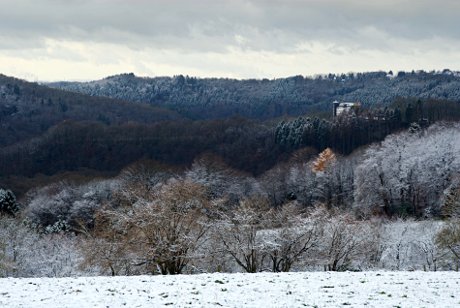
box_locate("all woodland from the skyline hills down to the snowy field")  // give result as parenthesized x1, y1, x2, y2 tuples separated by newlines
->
(0, 70, 460, 277)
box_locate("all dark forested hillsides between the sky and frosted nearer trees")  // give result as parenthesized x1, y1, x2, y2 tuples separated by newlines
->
(0, 71, 460, 195)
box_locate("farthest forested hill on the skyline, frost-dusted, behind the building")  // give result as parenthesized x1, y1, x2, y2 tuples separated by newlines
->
(49, 70, 460, 119)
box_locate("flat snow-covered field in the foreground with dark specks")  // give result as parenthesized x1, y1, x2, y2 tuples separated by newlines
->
(0, 272, 460, 308)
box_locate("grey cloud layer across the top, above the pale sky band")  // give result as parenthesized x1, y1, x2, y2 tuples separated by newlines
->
(0, 0, 460, 52)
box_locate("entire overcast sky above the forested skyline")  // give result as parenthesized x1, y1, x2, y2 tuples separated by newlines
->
(0, 0, 460, 81)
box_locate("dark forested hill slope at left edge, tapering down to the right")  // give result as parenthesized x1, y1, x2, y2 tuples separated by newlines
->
(0, 75, 180, 146)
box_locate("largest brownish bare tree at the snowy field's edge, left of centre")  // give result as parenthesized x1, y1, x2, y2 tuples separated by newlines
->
(81, 179, 212, 275)
